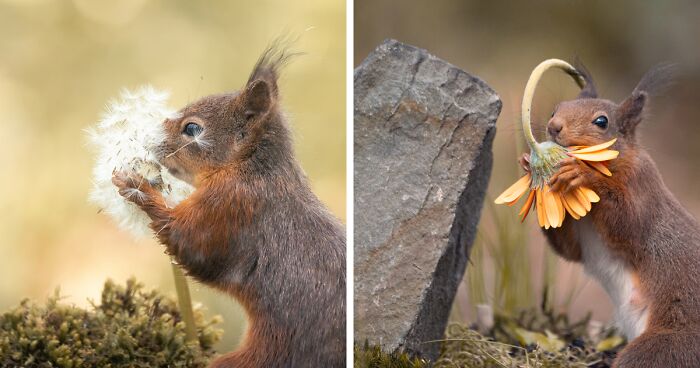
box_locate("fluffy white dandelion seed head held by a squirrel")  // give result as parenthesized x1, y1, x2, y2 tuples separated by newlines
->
(87, 86, 194, 237)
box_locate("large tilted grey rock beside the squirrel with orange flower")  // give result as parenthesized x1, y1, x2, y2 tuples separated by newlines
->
(354, 40, 501, 359)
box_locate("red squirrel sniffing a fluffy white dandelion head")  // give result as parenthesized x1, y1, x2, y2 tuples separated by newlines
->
(112, 45, 346, 368)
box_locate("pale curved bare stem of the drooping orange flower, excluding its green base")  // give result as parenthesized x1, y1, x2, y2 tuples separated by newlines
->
(521, 59, 586, 151)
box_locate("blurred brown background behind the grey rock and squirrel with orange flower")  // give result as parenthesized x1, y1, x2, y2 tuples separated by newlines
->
(354, 0, 700, 321)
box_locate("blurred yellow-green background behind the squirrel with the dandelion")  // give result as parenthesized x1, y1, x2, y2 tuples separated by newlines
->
(0, 0, 346, 351)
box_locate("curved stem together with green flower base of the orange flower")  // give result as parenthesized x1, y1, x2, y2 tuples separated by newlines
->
(521, 59, 586, 188)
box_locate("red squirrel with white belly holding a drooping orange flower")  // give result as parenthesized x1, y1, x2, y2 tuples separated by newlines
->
(520, 65, 700, 368)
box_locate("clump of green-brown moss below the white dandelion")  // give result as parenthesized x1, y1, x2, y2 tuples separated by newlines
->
(0, 279, 222, 368)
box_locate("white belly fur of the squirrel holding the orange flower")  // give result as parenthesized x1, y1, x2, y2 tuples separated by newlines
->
(576, 217, 649, 340)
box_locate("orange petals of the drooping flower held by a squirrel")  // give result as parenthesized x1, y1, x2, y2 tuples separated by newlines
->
(495, 139, 619, 229)
